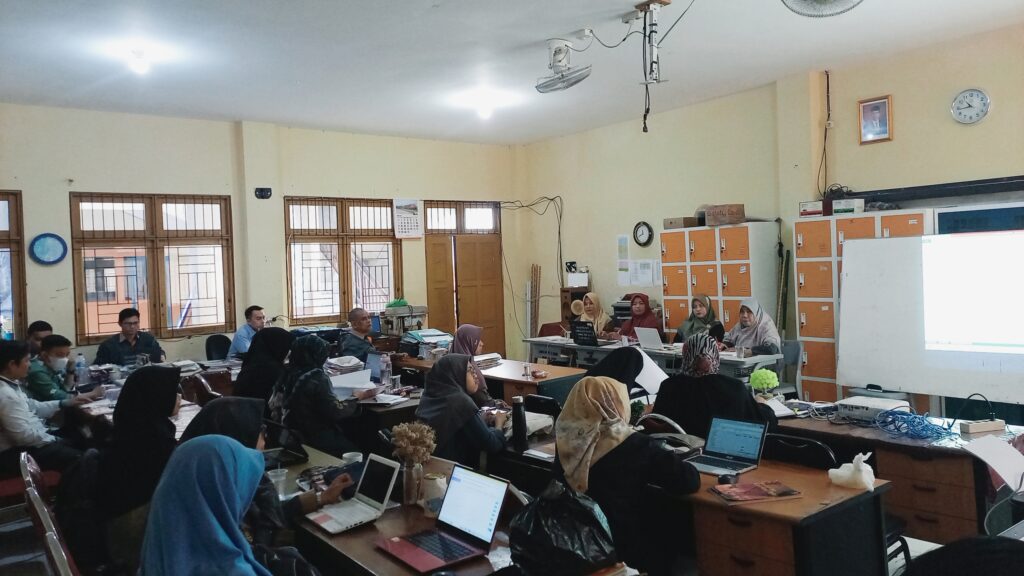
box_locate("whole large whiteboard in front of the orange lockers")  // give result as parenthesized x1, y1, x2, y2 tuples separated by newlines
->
(837, 232, 1024, 404)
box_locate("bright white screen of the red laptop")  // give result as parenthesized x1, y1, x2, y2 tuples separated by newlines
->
(437, 466, 508, 543)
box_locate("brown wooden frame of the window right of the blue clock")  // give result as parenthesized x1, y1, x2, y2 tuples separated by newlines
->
(69, 192, 236, 344)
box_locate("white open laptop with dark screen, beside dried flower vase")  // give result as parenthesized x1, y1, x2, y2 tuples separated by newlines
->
(306, 454, 399, 534)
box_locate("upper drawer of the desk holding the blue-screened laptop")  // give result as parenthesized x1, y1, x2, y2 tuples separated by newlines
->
(693, 506, 794, 561)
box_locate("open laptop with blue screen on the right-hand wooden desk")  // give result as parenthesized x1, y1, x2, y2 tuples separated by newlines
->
(686, 418, 767, 476)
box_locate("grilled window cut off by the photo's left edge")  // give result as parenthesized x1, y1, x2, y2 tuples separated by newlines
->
(0, 191, 27, 338)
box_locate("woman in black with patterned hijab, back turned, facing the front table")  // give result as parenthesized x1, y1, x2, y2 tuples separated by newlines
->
(653, 334, 778, 439)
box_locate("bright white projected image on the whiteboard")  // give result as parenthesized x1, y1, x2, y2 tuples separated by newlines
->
(922, 233, 1024, 354)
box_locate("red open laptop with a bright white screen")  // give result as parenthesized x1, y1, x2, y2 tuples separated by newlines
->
(377, 465, 509, 573)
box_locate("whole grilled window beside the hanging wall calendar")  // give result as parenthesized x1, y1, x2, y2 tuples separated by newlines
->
(285, 197, 401, 325)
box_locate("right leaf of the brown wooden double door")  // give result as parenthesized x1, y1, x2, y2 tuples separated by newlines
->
(455, 234, 505, 357)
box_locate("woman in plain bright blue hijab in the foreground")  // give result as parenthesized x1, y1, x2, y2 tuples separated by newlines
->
(138, 436, 317, 576)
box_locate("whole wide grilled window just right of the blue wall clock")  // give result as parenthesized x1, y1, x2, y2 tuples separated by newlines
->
(71, 193, 234, 343)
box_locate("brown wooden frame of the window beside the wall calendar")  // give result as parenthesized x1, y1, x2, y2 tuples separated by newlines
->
(284, 196, 404, 326)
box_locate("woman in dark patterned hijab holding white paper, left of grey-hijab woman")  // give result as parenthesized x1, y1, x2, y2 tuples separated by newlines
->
(270, 334, 373, 458)
